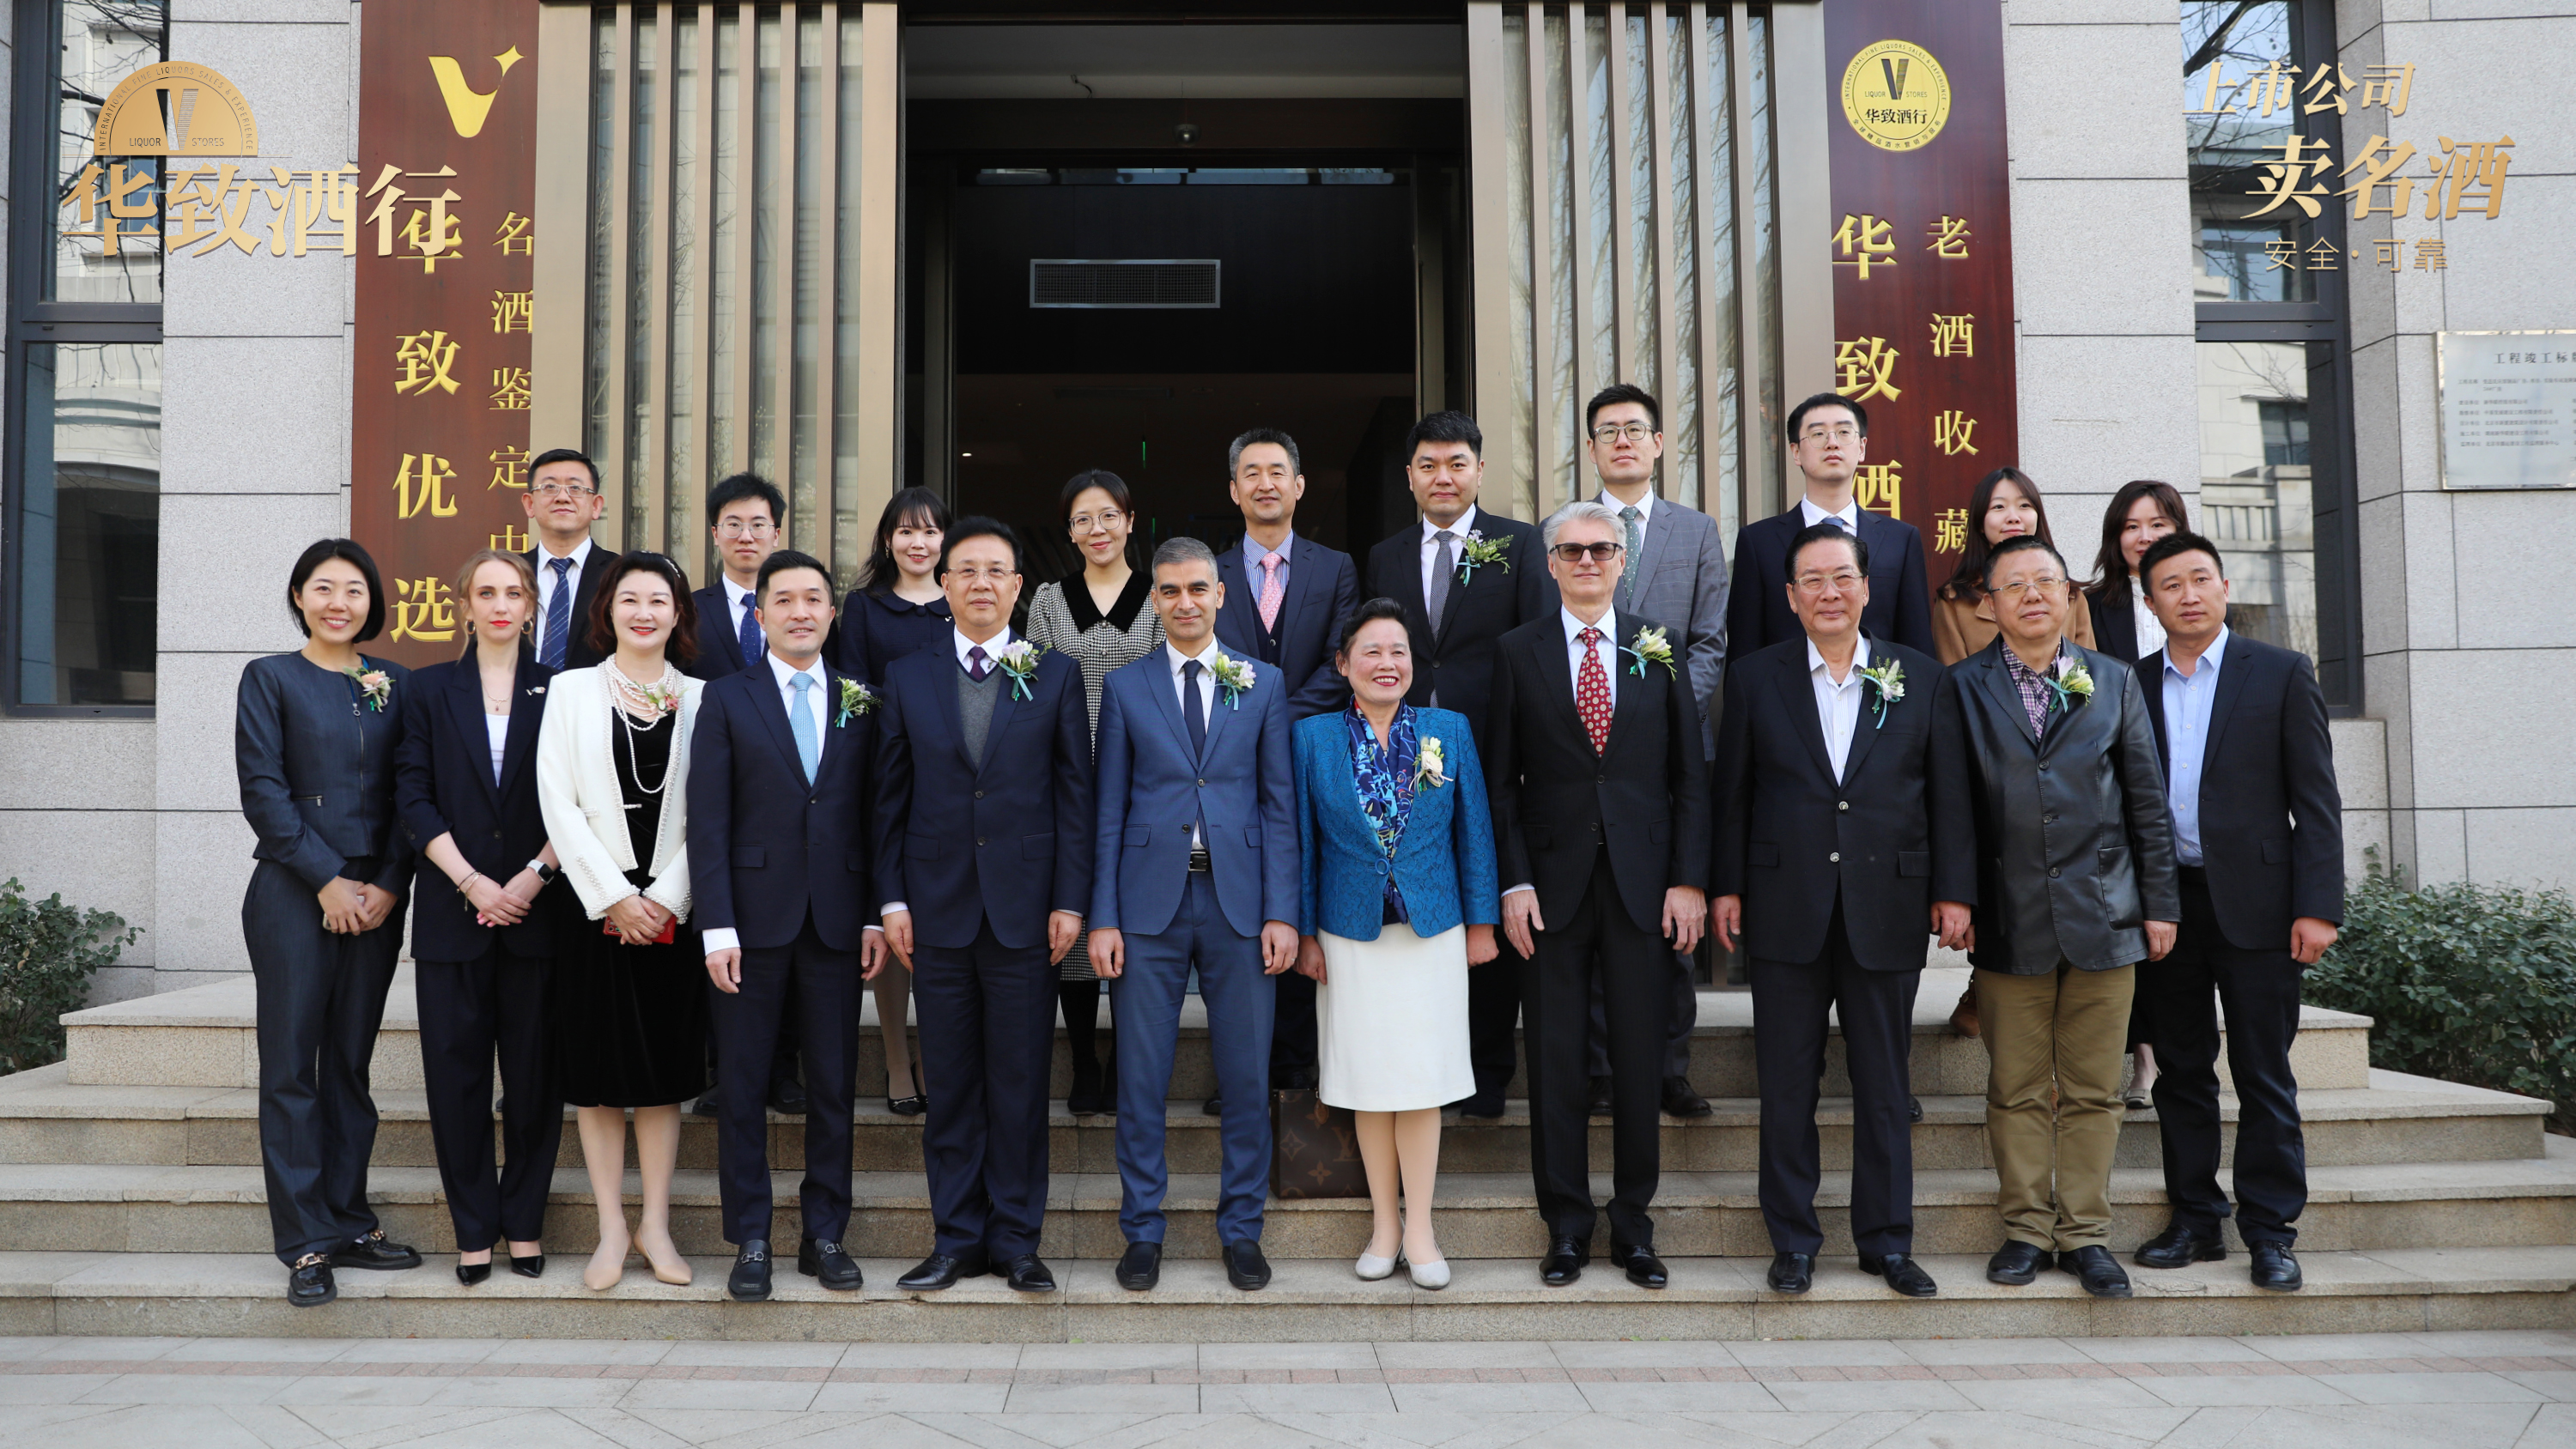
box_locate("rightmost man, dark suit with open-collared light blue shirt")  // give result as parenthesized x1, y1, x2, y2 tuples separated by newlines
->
(2136, 533, 2344, 1292)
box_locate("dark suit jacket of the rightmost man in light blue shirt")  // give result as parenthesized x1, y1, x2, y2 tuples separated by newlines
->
(2138, 631, 2344, 949)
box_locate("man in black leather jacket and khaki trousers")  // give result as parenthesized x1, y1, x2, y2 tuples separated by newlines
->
(1932, 533, 2182, 1297)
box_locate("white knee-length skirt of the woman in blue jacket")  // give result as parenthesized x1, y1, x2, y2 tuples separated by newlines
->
(1314, 924, 1476, 1112)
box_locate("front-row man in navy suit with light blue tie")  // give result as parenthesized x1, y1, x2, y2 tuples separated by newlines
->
(688, 549, 886, 1302)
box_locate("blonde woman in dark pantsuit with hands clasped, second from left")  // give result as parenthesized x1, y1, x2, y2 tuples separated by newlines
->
(394, 549, 564, 1284)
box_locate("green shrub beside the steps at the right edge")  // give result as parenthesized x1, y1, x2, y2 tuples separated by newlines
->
(2306, 852, 2576, 1132)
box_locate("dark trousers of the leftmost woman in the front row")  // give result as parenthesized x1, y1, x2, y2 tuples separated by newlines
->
(242, 859, 404, 1264)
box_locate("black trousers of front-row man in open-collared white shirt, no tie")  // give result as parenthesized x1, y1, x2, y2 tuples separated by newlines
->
(1752, 900, 1924, 1256)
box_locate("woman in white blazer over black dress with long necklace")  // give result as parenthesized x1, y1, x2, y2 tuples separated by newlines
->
(536, 554, 706, 1289)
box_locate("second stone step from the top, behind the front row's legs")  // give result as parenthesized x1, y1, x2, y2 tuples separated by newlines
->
(0, 1063, 2548, 1171)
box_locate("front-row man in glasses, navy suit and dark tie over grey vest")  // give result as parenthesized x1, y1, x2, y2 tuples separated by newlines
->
(876, 518, 1092, 1292)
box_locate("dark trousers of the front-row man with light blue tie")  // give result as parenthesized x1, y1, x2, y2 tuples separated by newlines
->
(708, 913, 860, 1243)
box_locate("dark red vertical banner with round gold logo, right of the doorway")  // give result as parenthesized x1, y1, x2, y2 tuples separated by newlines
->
(1824, 0, 2020, 587)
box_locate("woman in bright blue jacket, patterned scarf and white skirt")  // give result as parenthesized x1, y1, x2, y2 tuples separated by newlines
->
(1296, 600, 1502, 1287)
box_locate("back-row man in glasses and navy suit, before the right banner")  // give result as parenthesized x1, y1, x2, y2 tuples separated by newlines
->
(1726, 391, 1935, 662)
